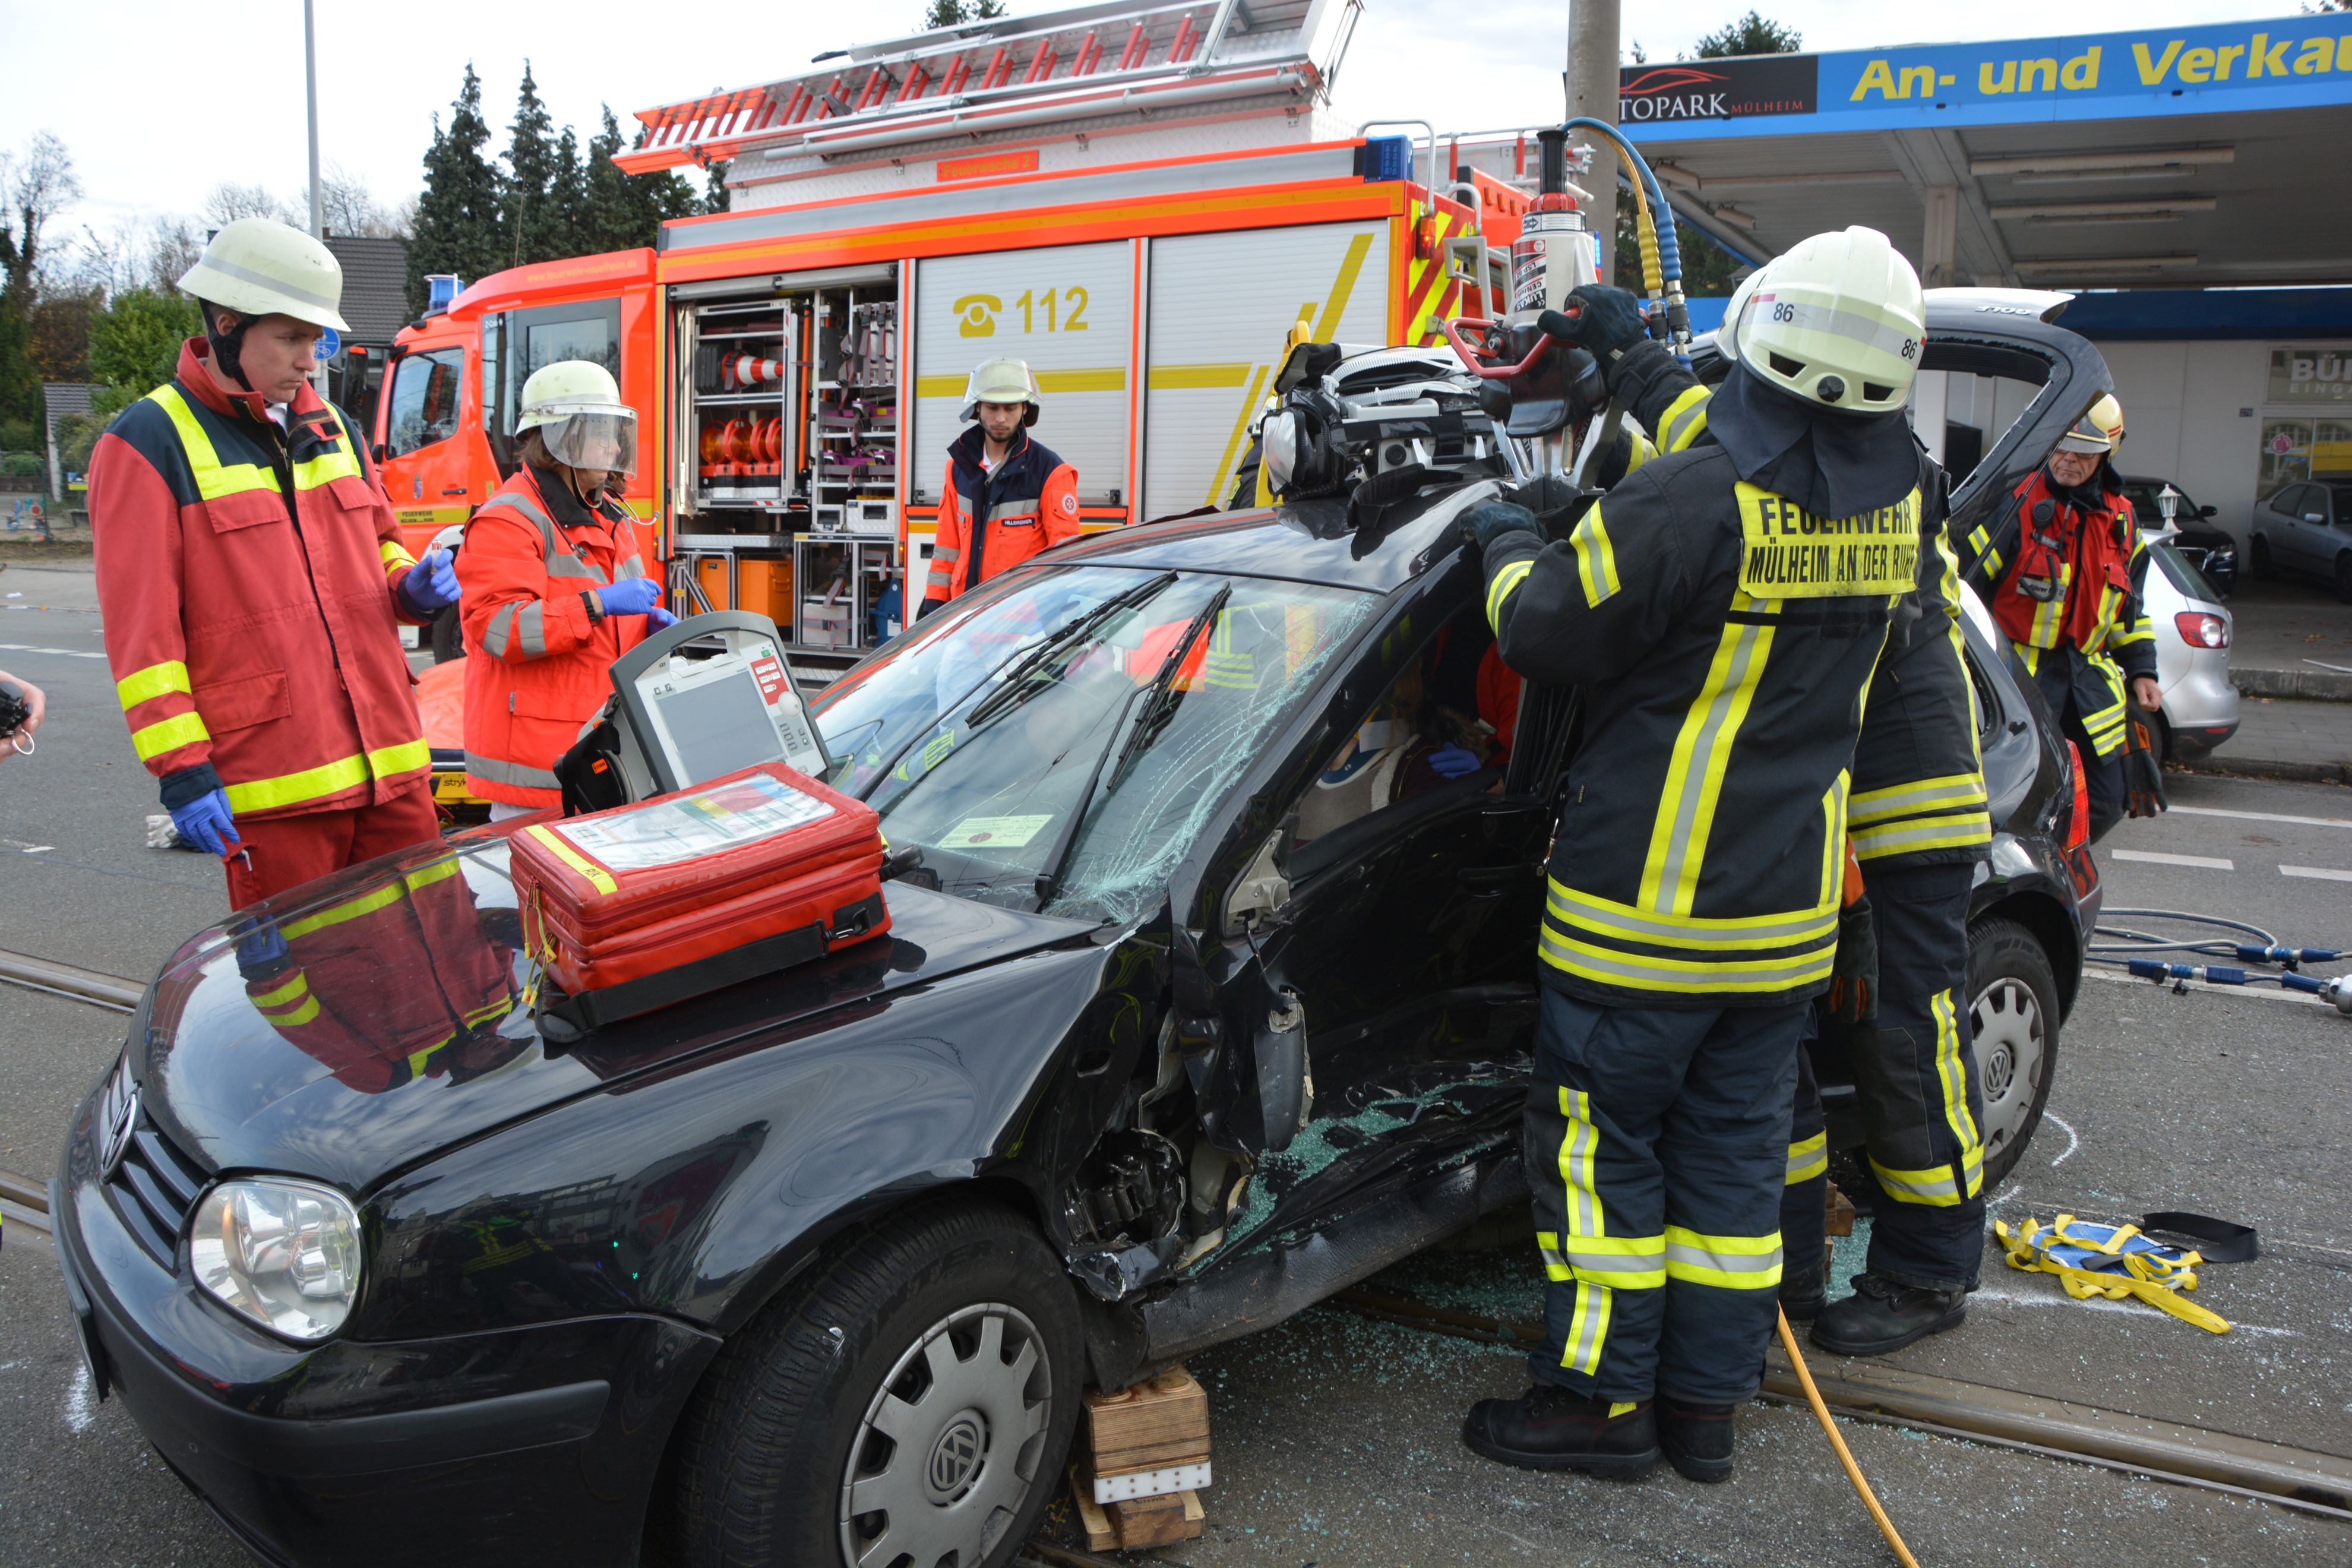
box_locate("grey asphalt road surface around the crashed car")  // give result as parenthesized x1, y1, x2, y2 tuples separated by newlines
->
(0, 557, 2352, 1568)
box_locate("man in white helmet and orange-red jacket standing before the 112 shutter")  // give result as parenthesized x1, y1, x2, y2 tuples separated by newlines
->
(919, 360, 1077, 616)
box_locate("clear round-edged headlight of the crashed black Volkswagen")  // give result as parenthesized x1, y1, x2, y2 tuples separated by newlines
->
(188, 1175, 360, 1340)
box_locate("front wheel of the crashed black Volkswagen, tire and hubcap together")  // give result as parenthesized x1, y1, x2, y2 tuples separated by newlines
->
(675, 1204, 1085, 1568)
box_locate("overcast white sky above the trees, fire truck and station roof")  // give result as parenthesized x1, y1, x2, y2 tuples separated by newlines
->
(0, 0, 2298, 242)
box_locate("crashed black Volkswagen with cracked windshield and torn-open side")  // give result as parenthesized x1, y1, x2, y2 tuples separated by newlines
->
(52, 293, 2105, 1568)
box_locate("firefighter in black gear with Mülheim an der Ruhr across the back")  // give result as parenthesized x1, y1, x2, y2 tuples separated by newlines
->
(1463, 228, 1926, 1481)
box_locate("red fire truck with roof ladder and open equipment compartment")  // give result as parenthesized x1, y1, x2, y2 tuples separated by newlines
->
(377, 0, 1536, 670)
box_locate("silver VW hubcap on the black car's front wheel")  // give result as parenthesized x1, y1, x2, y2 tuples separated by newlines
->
(840, 1303, 1054, 1568)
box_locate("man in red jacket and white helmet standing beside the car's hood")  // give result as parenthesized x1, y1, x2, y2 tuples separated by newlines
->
(89, 219, 456, 908)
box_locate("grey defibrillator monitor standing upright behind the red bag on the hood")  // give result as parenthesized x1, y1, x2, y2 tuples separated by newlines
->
(612, 609, 826, 799)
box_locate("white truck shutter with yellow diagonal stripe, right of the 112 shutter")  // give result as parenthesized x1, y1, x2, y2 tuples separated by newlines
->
(1139, 221, 1387, 517)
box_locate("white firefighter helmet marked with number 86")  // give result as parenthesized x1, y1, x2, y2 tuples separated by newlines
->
(1727, 228, 1926, 414)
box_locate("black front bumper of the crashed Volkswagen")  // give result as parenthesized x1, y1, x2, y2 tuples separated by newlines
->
(49, 1109, 717, 1568)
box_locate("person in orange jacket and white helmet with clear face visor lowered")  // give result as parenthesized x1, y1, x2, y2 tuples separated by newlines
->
(456, 360, 675, 823)
